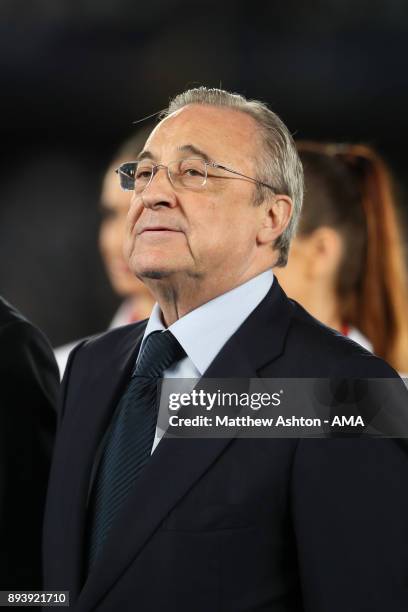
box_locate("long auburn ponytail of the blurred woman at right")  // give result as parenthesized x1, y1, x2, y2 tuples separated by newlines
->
(298, 142, 408, 372)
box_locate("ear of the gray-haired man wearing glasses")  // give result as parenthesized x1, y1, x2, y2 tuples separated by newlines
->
(257, 195, 293, 245)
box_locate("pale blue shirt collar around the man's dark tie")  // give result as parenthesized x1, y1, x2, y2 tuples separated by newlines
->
(142, 270, 273, 375)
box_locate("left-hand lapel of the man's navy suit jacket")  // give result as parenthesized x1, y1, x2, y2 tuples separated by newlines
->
(50, 325, 144, 601)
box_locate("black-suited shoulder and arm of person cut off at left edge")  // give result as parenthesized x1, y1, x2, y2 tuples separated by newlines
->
(0, 298, 59, 590)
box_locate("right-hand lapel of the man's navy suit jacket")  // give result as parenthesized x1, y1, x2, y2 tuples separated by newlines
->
(72, 282, 290, 612)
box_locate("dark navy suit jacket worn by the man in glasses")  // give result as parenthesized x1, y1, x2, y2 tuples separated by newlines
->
(44, 279, 408, 612)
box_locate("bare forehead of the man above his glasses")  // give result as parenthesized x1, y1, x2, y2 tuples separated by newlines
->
(145, 104, 258, 167)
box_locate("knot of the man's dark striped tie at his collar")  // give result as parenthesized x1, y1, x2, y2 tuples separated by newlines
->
(133, 331, 186, 378)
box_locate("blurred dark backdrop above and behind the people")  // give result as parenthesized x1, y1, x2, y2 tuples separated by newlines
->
(0, 0, 408, 345)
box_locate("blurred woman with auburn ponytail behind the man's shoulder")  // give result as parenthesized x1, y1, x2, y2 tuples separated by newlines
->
(277, 141, 408, 372)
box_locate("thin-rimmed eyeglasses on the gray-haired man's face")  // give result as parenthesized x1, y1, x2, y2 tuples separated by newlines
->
(115, 157, 276, 193)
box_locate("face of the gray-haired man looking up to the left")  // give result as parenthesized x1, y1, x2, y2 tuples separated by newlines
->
(125, 105, 270, 284)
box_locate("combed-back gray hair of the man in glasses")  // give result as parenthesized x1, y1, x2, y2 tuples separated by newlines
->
(161, 87, 303, 266)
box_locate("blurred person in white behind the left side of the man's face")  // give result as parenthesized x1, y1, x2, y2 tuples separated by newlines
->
(55, 126, 154, 378)
